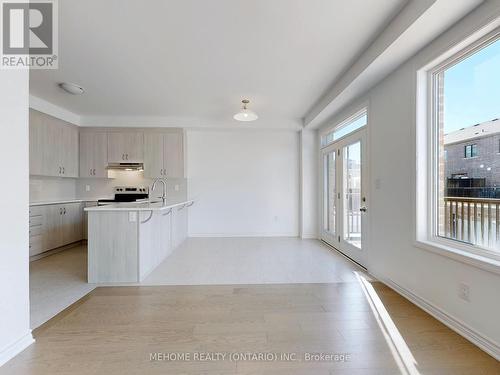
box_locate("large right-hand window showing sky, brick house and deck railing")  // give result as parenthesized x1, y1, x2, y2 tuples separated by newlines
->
(426, 30, 500, 259)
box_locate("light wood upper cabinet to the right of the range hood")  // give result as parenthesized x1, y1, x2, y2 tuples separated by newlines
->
(144, 131, 184, 178)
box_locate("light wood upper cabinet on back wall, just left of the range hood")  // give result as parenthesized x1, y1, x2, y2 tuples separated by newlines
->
(80, 131, 108, 178)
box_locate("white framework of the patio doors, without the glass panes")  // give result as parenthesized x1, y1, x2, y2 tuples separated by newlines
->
(318, 128, 370, 268)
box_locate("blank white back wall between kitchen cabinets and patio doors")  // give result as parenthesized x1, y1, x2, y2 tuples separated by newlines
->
(187, 129, 299, 236)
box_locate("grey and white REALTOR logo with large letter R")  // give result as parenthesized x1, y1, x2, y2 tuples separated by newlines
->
(1, 0, 58, 69)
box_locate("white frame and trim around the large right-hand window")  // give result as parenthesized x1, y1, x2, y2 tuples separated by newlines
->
(415, 25, 500, 274)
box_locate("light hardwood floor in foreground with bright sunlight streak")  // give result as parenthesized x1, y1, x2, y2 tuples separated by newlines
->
(4, 282, 500, 375)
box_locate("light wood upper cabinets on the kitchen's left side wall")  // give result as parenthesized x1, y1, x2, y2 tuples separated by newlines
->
(29, 110, 78, 177)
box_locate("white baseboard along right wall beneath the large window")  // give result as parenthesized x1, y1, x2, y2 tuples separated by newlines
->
(371, 273, 500, 361)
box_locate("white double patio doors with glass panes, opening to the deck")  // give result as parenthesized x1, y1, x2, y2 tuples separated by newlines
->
(322, 129, 367, 265)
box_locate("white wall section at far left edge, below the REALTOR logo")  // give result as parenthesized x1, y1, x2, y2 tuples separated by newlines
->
(0, 70, 33, 365)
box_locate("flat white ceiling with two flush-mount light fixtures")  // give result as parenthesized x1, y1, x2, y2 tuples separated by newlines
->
(30, 0, 406, 127)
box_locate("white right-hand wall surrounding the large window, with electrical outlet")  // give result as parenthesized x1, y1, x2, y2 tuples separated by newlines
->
(318, 2, 500, 353)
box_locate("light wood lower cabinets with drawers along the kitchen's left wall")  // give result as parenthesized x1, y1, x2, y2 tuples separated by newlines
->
(29, 203, 83, 256)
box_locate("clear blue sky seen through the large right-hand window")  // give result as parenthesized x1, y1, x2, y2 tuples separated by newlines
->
(444, 40, 500, 134)
